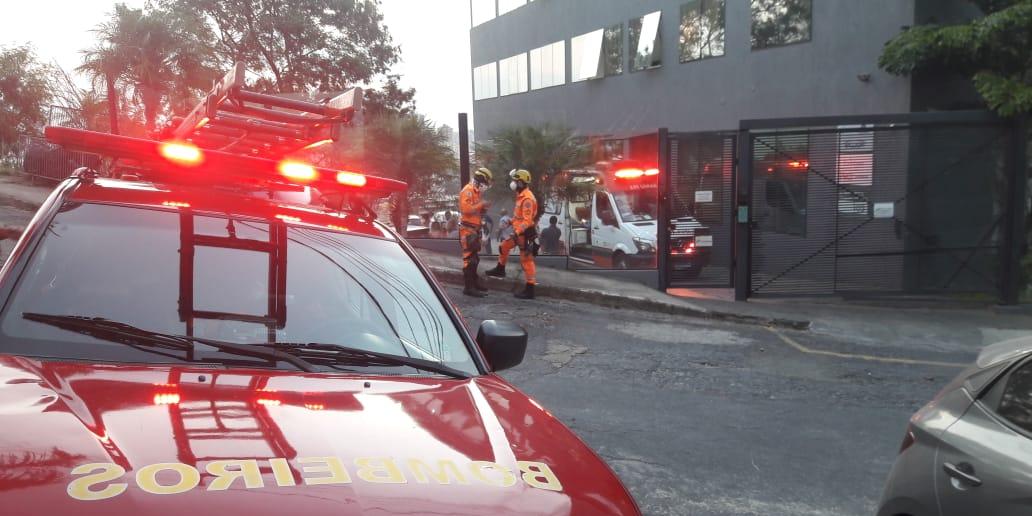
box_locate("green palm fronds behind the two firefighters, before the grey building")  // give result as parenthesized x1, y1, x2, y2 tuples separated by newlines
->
(476, 125, 591, 199)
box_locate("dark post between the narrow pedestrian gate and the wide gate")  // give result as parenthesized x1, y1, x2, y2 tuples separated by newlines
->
(734, 129, 752, 301)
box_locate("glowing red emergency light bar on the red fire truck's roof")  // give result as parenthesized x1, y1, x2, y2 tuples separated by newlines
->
(44, 126, 409, 194)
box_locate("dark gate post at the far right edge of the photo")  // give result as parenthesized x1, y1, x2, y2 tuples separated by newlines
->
(1000, 117, 1028, 304)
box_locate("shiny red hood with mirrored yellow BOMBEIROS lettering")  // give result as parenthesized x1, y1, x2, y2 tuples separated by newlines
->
(0, 356, 637, 515)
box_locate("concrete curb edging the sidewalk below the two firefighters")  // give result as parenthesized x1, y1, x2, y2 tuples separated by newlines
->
(429, 265, 810, 330)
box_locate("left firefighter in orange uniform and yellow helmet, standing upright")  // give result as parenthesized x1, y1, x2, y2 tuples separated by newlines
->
(458, 167, 493, 297)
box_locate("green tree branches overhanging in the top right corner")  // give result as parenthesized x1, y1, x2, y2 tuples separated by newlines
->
(878, 0, 1032, 117)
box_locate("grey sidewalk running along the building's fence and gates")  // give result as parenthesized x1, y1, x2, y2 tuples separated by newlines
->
(417, 249, 1032, 355)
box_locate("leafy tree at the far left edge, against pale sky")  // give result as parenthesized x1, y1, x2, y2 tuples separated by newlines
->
(0, 45, 54, 149)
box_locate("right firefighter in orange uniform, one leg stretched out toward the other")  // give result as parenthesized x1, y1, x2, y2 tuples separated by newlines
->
(487, 169, 538, 299)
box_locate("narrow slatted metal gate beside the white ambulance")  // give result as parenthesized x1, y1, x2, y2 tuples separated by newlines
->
(667, 132, 737, 288)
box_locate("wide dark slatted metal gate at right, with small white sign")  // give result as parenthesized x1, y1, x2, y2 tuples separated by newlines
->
(738, 112, 1025, 299)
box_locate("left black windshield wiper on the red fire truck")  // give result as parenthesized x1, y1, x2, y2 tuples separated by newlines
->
(22, 312, 318, 373)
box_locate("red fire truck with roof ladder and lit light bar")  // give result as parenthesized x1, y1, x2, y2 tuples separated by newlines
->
(0, 62, 639, 515)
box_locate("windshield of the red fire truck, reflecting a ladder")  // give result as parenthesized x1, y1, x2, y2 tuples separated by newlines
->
(0, 204, 477, 374)
